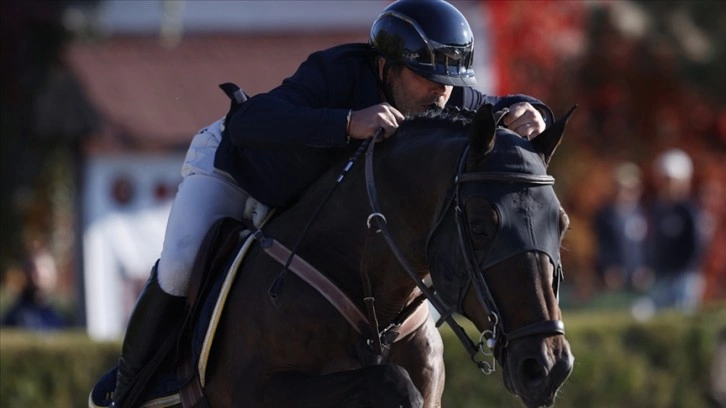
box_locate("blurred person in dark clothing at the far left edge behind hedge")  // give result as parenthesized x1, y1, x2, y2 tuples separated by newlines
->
(2, 245, 66, 330)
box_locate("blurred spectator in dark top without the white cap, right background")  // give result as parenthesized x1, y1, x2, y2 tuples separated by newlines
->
(595, 162, 652, 290)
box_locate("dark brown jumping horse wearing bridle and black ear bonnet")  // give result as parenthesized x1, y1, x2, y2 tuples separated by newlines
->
(122, 105, 574, 408)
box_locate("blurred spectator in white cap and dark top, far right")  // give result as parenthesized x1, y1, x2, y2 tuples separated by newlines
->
(648, 149, 705, 312)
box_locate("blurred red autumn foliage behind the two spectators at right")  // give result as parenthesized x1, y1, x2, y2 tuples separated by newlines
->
(485, 0, 726, 306)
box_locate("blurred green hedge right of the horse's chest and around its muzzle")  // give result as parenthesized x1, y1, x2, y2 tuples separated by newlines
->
(443, 307, 726, 408)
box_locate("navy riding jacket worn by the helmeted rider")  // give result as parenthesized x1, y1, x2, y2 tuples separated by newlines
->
(215, 44, 552, 207)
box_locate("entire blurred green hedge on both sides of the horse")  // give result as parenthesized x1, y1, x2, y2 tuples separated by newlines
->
(0, 307, 726, 408)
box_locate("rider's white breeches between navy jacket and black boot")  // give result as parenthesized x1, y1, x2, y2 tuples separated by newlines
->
(158, 120, 268, 296)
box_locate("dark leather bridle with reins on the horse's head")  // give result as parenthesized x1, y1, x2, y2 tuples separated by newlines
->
(365, 126, 565, 374)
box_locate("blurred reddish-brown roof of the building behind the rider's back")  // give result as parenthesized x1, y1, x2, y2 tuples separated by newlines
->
(67, 32, 367, 150)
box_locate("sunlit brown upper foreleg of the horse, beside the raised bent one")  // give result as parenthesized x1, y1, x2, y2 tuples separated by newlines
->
(389, 319, 446, 408)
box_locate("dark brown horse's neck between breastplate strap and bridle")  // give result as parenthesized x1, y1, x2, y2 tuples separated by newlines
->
(273, 135, 463, 323)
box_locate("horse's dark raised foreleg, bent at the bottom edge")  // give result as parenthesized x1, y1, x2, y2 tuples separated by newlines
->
(263, 364, 423, 408)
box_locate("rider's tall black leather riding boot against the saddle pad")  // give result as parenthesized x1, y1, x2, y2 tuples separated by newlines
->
(113, 265, 186, 408)
